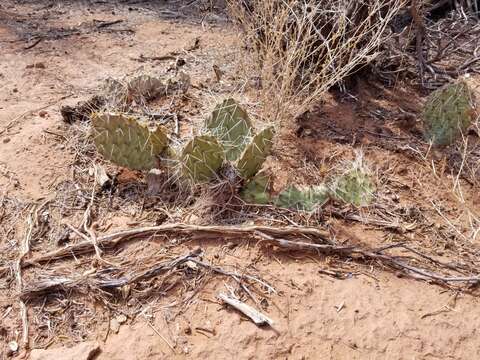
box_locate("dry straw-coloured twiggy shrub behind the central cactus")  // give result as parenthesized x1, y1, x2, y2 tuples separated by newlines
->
(229, 0, 406, 120)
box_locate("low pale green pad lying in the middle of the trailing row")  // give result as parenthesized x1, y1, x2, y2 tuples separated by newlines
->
(275, 185, 330, 211)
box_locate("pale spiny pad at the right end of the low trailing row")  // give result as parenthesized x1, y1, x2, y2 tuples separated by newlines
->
(333, 167, 375, 206)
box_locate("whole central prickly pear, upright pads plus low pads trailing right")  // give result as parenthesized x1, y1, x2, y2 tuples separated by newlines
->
(91, 99, 375, 211)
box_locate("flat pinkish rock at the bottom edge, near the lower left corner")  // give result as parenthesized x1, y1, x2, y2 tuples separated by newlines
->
(30, 342, 101, 360)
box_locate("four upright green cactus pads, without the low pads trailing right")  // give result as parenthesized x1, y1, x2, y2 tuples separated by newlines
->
(92, 99, 274, 184)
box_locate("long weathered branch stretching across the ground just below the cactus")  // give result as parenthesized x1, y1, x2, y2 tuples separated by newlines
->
(10, 224, 480, 294)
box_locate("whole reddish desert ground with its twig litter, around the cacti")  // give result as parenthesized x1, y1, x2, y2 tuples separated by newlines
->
(0, 0, 480, 360)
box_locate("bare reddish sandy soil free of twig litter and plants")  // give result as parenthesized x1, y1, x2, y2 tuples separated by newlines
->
(0, 0, 480, 360)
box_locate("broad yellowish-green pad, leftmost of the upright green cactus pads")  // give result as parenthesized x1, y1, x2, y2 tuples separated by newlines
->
(92, 113, 168, 170)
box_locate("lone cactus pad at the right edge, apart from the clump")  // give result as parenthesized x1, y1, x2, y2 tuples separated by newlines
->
(423, 81, 474, 145)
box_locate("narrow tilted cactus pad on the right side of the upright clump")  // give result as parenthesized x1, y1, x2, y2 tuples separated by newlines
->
(236, 126, 274, 179)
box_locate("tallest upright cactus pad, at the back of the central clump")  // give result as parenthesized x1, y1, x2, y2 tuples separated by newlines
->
(205, 99, 252, 161)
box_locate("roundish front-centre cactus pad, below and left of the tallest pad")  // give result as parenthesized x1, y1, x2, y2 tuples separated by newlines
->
(179, 135, 225, 183)
